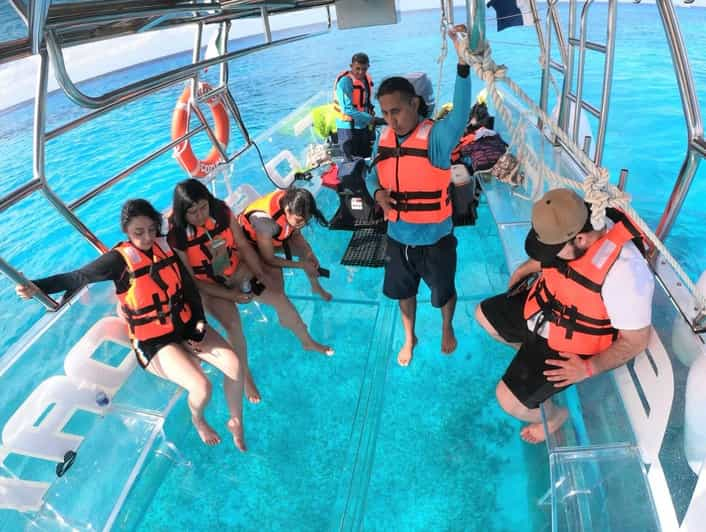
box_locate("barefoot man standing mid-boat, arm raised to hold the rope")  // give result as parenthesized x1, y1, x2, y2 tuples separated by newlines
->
(367, 25, 471, 366)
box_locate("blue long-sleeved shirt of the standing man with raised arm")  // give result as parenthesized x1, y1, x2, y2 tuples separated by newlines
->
(366, 67, 471, 246)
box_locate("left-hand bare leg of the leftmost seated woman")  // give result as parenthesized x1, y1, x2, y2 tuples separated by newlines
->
(147, 344, 221, 445)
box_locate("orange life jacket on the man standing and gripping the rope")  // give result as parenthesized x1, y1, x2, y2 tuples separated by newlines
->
(372, 119, 451, 223)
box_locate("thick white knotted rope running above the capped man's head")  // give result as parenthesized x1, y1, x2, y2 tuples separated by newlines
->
(464, 37, 696, 297)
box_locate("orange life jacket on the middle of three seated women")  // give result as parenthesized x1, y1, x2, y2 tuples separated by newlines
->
(186, 217, 239, 284)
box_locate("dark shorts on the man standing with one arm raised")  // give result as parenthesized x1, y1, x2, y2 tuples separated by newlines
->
(382, 234, 456, 308)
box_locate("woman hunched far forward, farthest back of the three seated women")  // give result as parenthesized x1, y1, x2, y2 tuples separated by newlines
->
(238, 188, 333, 350)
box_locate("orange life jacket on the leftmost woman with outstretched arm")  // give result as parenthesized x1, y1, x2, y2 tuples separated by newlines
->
(115, 238, 191, 341)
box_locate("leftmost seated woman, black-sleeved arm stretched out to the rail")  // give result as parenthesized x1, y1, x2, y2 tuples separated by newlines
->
(15, 199, 246, 451)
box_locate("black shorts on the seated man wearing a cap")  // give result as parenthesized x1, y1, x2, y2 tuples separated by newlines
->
(481, 292, 563, 409)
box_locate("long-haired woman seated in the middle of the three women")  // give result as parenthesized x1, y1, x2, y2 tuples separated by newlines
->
(169, 179, 333, 366)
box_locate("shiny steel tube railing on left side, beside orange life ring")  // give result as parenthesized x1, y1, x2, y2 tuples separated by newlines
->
(0, 7, 331, 311)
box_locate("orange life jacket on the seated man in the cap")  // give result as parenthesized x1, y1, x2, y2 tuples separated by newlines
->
(524, 209, 644, 355)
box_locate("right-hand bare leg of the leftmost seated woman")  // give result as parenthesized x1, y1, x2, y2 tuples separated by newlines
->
(189, 325, 247, 451)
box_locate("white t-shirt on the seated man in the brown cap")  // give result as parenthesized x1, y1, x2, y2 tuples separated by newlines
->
(527, 232, 655, 338)
